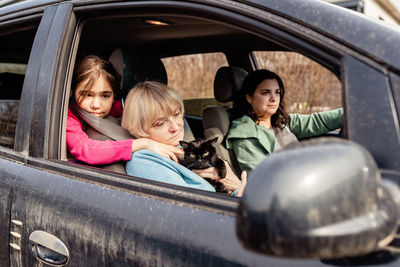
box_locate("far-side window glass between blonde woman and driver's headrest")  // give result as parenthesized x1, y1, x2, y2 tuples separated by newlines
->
(162, 53, 228, 116)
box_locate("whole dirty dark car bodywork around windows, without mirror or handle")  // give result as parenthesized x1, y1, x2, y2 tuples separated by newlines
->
(0, 0, 400, 266)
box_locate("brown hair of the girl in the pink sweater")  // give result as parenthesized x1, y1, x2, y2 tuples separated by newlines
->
(72, 55, 121, 104)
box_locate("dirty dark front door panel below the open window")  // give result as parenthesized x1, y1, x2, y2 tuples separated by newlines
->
(9, 158, 322, 266)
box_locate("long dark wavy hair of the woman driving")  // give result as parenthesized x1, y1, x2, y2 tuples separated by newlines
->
(233, 70, 289, 128)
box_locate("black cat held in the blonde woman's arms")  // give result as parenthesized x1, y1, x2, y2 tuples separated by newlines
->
(179, 137, 226, 192)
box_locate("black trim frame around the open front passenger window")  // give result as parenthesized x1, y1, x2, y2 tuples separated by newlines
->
(43, 1, 378, 211)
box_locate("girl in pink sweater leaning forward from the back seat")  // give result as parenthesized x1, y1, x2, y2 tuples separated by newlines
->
(66, 55, 183, 165)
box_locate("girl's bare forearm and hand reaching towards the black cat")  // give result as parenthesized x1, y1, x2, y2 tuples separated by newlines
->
(132, 138, 184, 162)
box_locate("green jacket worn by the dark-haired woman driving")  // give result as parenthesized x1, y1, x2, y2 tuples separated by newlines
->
(226, 108, 343, 172)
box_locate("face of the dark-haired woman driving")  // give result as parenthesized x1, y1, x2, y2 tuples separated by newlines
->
(246, 79, 281, 120)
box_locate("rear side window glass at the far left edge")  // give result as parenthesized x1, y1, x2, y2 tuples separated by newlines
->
(0, 24, 37, 148)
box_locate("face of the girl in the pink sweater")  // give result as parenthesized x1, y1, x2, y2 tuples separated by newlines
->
(75, 77, 114, 118)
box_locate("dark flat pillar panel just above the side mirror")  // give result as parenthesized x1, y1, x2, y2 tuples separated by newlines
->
(344, 57, 400, 170)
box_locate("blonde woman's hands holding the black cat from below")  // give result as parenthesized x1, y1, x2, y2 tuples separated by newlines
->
(192, 161, 247, 196)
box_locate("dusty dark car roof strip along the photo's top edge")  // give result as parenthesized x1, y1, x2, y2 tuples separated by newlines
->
(0, 0, 400, 71)
